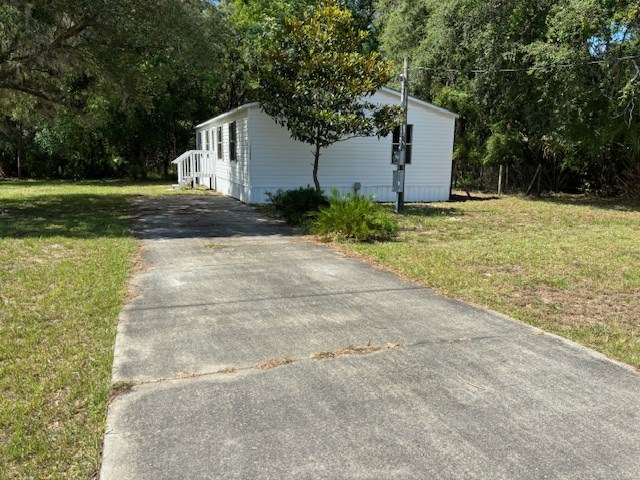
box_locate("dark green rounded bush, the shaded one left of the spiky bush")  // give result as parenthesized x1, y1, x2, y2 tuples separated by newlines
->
(267, 187, 329, 226)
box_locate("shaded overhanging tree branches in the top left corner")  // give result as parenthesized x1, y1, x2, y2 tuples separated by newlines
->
(0, 0, 190, 102)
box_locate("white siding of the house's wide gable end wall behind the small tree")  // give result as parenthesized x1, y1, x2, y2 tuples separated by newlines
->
(251, 91, 455, 203)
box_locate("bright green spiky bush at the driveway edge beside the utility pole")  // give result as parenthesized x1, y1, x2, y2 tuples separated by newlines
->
(311, 189, 398, 242)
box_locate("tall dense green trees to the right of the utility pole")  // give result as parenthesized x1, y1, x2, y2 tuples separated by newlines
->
(378, 0, 640, 195)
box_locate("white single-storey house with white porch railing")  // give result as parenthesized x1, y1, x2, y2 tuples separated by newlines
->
(173, 88, 458, 203)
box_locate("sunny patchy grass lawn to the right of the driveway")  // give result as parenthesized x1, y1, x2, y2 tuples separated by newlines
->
(344, 196, 640, 367)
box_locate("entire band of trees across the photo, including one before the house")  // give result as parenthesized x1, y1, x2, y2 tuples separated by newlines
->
(0, 0, 640, 193)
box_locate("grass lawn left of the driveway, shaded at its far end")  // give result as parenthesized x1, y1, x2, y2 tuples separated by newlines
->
(0, 181, 215, 479)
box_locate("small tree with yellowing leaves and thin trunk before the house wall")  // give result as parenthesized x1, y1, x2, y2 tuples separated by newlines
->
(258, 1, 400, 192)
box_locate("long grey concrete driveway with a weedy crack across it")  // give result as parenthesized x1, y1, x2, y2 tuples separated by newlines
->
(100, 196, 640, 480)
